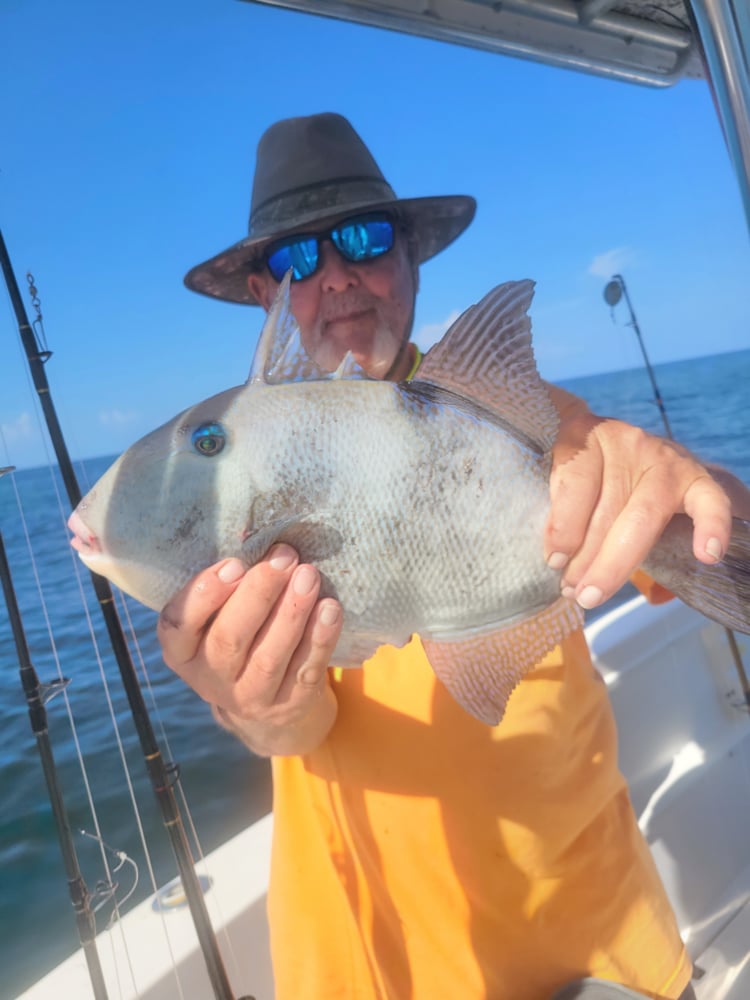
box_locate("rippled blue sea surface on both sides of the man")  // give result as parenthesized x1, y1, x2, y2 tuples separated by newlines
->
(0, 350, 750, 1000)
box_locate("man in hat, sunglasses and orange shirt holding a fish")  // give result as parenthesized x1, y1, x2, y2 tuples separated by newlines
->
(159, 114, 750, 1000)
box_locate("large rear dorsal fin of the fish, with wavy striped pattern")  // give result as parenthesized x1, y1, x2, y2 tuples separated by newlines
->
(415, 279, 558, 451)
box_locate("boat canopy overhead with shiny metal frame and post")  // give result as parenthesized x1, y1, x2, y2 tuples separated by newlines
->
(241, 0, 750, 233)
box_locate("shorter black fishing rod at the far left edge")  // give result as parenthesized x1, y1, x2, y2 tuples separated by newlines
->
(0, 466, 108, 1000)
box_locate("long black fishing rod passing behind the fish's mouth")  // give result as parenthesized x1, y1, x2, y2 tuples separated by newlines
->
(0, 230, 252, 1000)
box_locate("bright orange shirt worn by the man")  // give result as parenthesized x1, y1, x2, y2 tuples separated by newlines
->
(269, 632, 690, 1000)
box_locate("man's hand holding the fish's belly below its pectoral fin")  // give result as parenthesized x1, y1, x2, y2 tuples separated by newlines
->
(162, 545, 342, 755)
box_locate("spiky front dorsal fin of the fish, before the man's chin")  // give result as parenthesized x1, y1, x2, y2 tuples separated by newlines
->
(247, 269, 368, 385)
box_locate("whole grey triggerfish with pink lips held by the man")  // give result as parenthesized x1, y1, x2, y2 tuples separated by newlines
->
(69, 278, 750, 726)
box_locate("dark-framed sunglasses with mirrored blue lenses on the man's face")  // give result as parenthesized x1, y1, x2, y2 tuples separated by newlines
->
(265, 213, 394, 281)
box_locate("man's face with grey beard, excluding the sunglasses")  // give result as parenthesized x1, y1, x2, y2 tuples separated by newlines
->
(248, 234, 417, 378)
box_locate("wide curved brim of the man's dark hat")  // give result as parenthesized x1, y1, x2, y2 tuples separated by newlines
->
(184, 194, 477, 306)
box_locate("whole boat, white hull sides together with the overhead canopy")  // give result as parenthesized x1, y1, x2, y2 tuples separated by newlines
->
(5, 0, 750, 1000)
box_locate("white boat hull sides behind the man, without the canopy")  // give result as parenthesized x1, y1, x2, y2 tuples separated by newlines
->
(18, 597, 750, 1000)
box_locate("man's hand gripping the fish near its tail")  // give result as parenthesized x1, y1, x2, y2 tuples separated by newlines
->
(545, 387, 748, 608)
